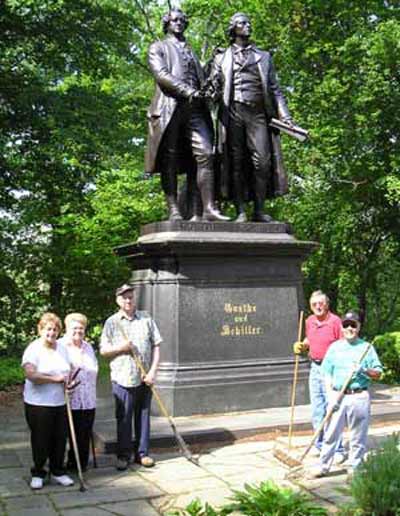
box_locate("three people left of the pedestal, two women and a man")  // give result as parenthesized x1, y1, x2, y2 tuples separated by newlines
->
(22, 285, 161, 490)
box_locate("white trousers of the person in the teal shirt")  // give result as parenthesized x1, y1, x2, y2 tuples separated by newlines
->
(320, 391, 371, 470)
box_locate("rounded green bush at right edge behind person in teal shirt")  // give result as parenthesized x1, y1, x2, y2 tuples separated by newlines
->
(373, 332, 400, 383)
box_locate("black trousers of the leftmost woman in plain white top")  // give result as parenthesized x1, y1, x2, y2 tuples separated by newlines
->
(25, 403, 67, 478)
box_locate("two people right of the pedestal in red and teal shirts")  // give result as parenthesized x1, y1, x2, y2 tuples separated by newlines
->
(293, 290, 382, 477)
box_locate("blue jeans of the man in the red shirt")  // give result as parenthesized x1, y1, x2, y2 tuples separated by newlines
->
(308, 362, 344, 453)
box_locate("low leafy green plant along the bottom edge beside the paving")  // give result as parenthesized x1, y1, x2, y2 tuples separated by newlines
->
(170, 481, 327, 516)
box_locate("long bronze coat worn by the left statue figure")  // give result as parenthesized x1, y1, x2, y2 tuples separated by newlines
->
(145, 36, 212, 173)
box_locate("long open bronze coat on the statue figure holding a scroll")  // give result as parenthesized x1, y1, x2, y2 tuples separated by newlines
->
(210, 46, 290, 199)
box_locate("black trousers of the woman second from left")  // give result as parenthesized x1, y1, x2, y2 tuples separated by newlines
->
(67, 409, 96, 470)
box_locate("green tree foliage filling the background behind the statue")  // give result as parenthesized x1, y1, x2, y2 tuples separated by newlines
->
(0, 0, 400, 355)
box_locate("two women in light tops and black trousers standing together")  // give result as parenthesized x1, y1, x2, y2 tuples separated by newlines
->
(22, 312, 98, 489)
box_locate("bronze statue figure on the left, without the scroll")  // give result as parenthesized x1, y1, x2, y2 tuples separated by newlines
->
(145, 9, 229, 221)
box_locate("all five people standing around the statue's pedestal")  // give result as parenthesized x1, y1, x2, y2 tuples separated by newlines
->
(22, 284, 382, 489)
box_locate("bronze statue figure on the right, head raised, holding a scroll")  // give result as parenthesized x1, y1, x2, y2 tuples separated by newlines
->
(209, 13, 293, 222)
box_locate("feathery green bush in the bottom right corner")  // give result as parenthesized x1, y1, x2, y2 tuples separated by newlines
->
(341, 435, 400, 516)
